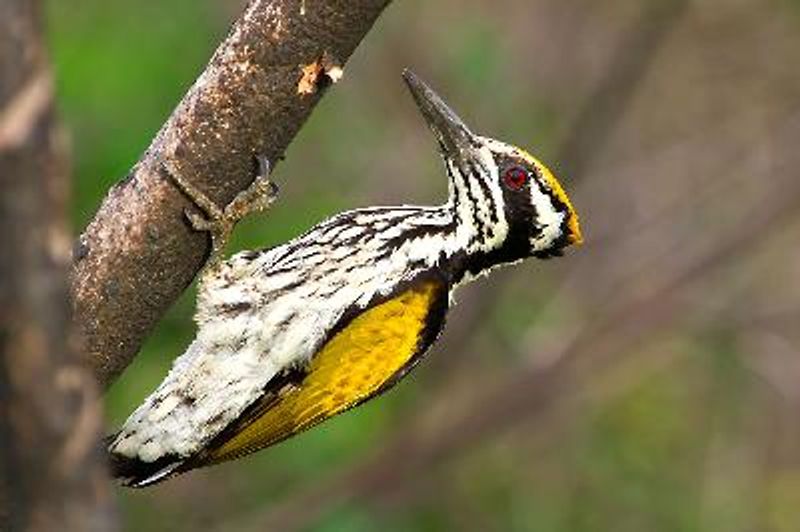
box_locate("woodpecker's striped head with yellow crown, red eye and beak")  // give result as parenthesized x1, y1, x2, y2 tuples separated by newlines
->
(403, 70, 582, 262)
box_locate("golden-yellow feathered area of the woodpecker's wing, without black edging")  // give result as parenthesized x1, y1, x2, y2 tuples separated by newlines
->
(204, 282, 437, 462)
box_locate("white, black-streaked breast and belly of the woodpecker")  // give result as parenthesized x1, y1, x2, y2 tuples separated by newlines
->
(110, 207, 456, 470)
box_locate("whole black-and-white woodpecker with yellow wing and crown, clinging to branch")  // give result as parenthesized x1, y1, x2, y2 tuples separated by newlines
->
(108, 71, 582, 487)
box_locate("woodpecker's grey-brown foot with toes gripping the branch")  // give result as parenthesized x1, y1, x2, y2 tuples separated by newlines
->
(161, 156, 278, 277)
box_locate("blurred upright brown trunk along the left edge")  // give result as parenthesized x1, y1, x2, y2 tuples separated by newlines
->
(0, 0, 113, 531)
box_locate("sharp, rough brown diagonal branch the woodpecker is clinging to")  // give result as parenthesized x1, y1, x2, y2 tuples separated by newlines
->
(72, 0, 389, 385)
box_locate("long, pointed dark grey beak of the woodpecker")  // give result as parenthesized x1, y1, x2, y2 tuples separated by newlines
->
(403, 70, 478, 161)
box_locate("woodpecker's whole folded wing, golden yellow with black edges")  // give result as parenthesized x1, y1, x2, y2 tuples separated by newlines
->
(186, 278, 447, 468)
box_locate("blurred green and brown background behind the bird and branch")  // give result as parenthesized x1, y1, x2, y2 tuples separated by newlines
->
(47, 0, 800, 532)
